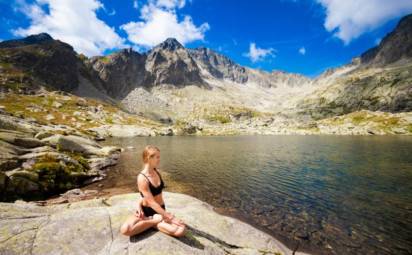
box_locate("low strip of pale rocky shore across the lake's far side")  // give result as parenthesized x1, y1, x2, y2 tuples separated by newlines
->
(87, 110, 412, 137)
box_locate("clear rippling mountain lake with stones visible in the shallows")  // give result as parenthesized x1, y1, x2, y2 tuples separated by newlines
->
(87, 135, 412, 254)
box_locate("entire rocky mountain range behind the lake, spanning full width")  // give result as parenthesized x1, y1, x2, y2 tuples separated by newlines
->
(0, 15, 412, 125)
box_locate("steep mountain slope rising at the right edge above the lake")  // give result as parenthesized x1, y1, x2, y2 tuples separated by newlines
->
(296, 15, 412, 118)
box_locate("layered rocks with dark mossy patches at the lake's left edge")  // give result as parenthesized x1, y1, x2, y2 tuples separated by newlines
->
(0, 110, 121, 201)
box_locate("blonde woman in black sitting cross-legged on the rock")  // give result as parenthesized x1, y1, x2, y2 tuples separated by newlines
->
(120, 145, 186, 237)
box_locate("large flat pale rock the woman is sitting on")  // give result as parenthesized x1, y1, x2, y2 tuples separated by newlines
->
(0, 192, 303, 255)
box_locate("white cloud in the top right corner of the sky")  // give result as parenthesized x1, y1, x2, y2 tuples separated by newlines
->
(317, 0, 412, 44)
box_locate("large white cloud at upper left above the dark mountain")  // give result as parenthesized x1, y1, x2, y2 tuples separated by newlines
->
(12, 0, 125, 56)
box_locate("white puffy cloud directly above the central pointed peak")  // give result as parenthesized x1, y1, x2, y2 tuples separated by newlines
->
(120, 0, 210, 48)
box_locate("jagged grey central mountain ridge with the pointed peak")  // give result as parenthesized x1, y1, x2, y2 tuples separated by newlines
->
(86, 38, 309, 99)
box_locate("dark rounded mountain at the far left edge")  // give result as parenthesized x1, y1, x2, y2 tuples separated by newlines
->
(0, 33, 83, 91)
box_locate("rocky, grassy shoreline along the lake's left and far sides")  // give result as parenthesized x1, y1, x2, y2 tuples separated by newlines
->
(0, 92, 412, 201)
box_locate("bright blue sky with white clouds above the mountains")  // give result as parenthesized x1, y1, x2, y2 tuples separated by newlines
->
(0, 0, 412, 77)
